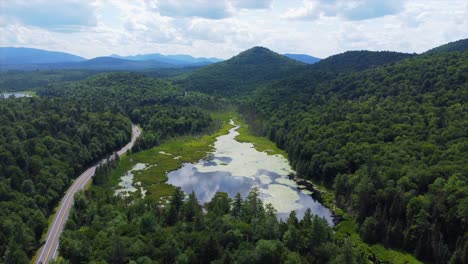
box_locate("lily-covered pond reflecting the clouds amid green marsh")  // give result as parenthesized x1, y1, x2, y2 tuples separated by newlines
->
(168, 120, 333, 225)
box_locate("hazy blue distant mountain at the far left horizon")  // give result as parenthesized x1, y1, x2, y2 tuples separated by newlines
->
(0, 47, 85, 65)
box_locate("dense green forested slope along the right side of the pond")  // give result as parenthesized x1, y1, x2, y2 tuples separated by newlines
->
(240, 52, 468, 263)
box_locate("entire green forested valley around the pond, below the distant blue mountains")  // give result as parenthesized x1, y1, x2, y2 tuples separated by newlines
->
(0, 37, 468, 263)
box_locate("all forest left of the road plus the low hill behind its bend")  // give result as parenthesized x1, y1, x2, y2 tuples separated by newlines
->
(0, 73, 217, 263)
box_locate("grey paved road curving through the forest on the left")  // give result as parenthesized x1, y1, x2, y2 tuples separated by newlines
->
(36, 125, 141, 264)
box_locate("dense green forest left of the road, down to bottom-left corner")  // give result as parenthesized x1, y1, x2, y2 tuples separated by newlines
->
(0, 97, 131, 263)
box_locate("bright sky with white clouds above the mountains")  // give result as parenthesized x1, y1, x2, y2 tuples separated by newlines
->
(0, 0, 468, 59)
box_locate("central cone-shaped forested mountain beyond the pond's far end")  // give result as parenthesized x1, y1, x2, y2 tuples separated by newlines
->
(175, 47, 306, 95)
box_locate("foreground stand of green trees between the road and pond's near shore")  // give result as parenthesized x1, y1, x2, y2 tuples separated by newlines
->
(59, 188, 366, 263)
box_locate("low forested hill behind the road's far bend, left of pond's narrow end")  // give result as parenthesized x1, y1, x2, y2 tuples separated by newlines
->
(38, 73, 221, 150)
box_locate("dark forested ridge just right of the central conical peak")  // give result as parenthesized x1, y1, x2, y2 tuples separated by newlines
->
(310, 50, 414, 72)
